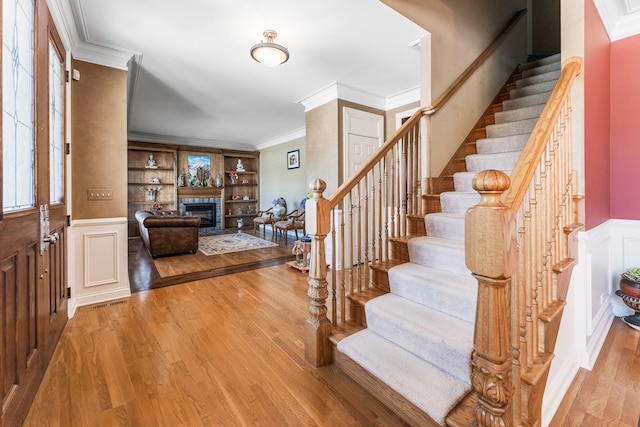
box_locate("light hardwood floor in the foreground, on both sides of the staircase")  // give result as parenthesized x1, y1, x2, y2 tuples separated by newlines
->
(24, 266, 640, 427)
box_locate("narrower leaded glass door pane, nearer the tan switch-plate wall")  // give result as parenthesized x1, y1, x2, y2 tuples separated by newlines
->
(49, 41, 64, 204)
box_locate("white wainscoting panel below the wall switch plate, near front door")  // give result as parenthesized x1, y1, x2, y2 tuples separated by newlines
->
(68, 218, 131, 316)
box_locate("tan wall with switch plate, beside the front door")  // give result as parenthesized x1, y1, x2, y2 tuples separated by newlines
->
(71, 60, 127, 220)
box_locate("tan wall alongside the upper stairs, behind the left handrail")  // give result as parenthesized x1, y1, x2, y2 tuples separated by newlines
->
(383, 0, 527, 176)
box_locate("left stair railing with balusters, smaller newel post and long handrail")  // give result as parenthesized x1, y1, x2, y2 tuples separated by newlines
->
(304, 10, 526, 367)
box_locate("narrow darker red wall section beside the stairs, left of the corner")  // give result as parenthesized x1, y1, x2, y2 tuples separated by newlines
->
(584, 0, 611, 230)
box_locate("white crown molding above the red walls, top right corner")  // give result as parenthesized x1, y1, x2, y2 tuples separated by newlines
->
(593, 0, 640, 42)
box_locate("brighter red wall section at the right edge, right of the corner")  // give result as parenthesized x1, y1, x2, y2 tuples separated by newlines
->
(611, 35, 640, 219)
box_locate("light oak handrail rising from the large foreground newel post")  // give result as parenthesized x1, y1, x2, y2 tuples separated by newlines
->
(502, 56, 582, 211)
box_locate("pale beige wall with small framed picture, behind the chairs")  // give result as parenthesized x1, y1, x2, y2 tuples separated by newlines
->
(260, 138, 309, 212)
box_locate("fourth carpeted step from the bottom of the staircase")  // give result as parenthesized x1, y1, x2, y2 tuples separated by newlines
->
(408, 236, 471, 274)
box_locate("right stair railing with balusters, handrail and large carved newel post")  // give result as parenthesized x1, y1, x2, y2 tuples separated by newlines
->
(465, 58, 582, 426)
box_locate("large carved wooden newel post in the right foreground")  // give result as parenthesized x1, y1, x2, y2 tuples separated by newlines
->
(465, 170, 517, 427)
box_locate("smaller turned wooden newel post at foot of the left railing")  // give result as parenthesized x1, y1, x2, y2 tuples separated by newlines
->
(304, 179, 331, 367)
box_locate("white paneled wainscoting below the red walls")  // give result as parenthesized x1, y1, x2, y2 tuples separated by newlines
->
(542, 219, 640, 426)
